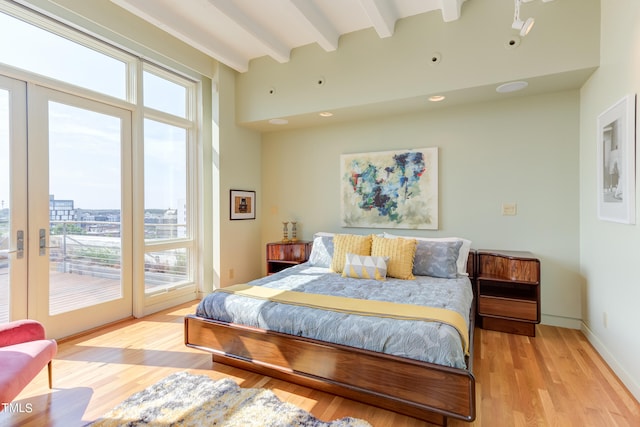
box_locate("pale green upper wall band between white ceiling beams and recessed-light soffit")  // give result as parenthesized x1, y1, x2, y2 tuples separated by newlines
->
(236, 0, 599, 126)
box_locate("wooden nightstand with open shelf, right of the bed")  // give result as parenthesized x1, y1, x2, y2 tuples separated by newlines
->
(476, 250, 540, 337)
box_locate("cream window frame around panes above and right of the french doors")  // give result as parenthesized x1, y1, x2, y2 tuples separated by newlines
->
(0, 2, 204, 317)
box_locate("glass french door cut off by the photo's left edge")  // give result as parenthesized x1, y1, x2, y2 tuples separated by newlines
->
(0, 76, 27, 323)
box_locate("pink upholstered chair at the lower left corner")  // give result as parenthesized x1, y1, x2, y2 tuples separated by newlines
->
(0, 320, 58, 411)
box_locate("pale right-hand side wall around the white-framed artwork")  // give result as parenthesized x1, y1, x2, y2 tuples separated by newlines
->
(580, 0, 640, 399)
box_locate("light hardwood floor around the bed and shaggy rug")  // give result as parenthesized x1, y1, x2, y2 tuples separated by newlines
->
(0, 302, 640, 427)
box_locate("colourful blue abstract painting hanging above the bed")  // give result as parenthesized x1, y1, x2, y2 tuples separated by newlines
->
(340, 147, 438, 230)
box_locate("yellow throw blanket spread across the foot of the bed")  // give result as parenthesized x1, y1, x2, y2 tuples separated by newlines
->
(215, 285, 469, 355)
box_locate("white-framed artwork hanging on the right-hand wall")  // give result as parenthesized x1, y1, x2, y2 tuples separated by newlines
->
(597, 95, 636, 224)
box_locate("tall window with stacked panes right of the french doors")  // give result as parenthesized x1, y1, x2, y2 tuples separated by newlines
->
(143, 64, 196, 296)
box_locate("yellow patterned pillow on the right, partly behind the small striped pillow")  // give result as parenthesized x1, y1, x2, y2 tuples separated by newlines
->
(371, 235, 417, 280)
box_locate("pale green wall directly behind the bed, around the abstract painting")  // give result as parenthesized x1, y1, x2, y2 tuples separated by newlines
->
(262, 91, 582, 328)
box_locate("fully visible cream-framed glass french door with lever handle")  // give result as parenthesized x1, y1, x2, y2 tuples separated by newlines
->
(0, 78, 132, 337)
